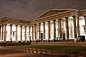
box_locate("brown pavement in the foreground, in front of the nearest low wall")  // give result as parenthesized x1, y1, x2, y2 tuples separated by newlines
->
(0, 49, 65, 57)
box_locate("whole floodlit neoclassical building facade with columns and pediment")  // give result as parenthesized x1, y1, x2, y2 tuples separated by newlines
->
(0, 9, 86, 42)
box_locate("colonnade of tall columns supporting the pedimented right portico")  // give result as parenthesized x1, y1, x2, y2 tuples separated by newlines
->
(34, 16, 80, 40)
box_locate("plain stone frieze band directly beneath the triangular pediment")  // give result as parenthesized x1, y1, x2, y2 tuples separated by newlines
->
(35, 12, 77, 23)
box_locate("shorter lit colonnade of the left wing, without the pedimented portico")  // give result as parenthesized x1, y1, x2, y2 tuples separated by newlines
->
(0, 24, 30, 42)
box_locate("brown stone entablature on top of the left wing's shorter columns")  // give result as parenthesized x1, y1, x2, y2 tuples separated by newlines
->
(0, 17, 30, 25)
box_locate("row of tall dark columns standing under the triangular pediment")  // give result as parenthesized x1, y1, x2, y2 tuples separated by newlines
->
(35, 16, 78, 40)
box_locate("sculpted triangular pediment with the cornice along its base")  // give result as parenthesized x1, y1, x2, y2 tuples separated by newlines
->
(34, 9, 78, 21)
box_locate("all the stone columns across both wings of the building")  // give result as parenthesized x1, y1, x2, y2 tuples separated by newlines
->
(0, 16, 86, 41)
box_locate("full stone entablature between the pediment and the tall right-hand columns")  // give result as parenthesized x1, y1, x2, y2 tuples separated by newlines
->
(35, 10, 78, 23)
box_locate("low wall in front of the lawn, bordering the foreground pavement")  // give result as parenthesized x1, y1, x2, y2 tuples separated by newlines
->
(0, 46, 86, 57)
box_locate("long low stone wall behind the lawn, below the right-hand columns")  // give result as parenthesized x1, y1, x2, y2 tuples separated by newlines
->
(31, 42, 86, 46)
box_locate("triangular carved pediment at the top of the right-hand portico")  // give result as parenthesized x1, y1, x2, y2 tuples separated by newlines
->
(36, 9, 75, 19)
